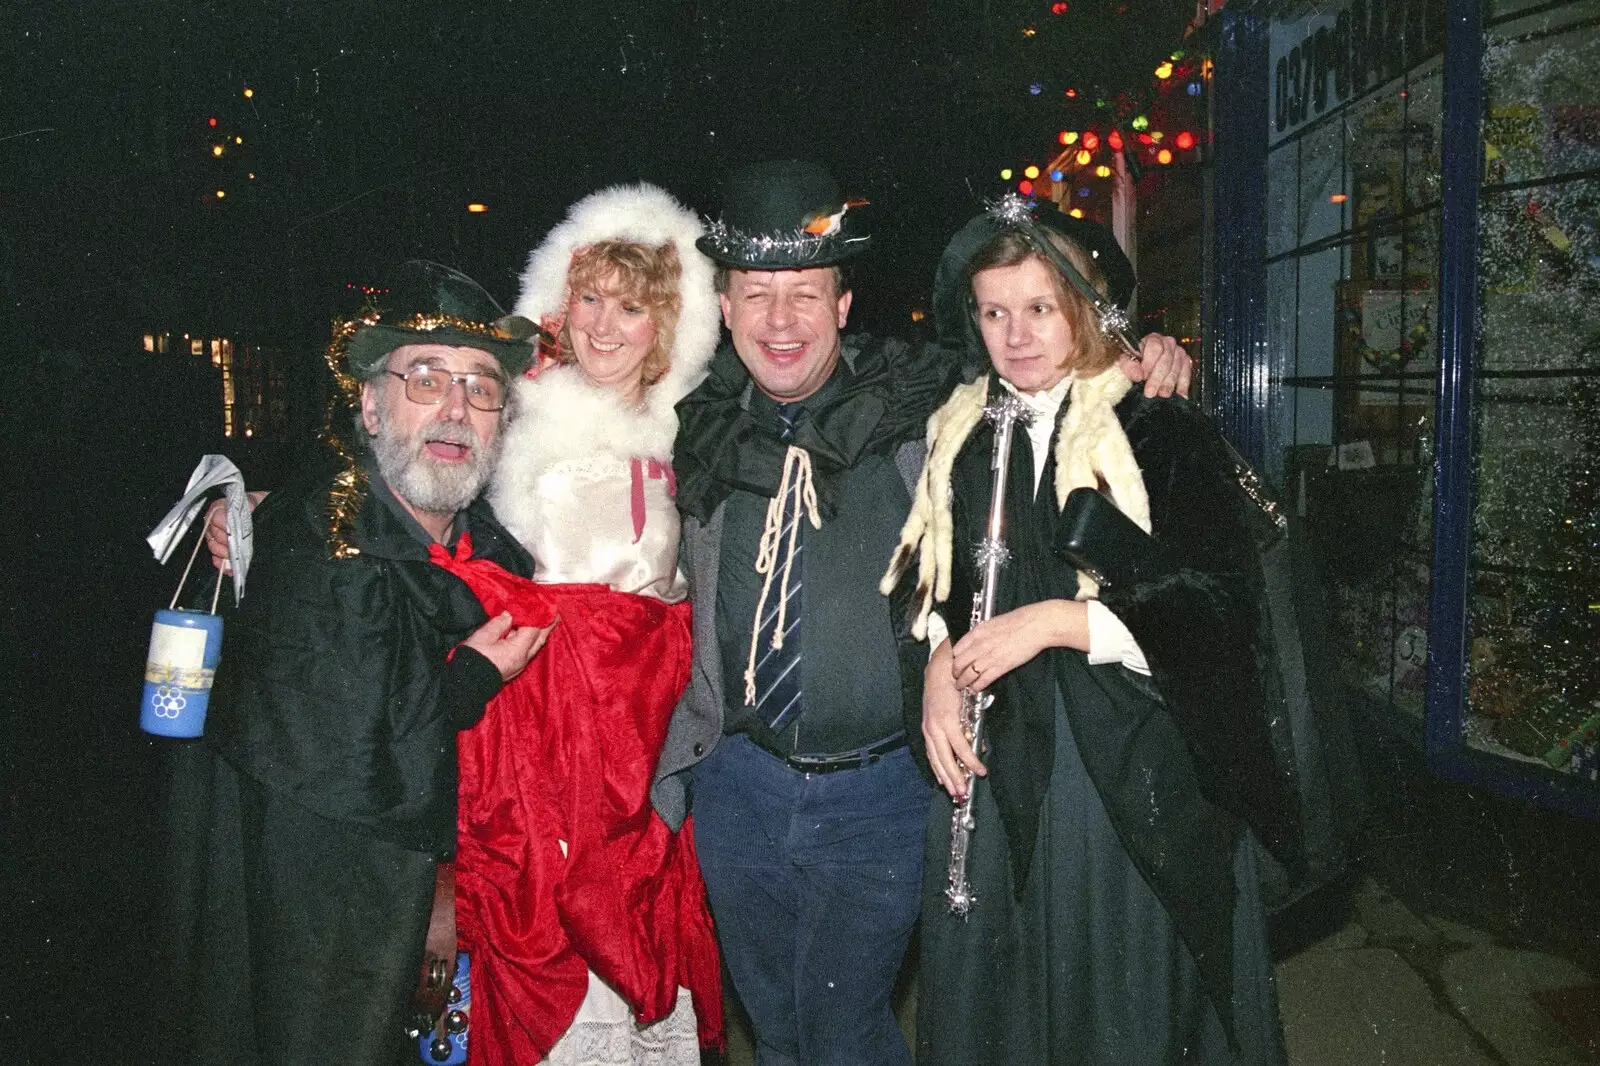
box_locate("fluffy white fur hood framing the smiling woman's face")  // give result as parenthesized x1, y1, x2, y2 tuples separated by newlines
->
(515, 182, 722, 415)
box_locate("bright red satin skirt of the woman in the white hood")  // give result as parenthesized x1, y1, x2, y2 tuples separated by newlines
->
(432, 536, 723, 1066)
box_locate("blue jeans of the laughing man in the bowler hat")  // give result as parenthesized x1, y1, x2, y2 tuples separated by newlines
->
(693, 735, 933, 1066)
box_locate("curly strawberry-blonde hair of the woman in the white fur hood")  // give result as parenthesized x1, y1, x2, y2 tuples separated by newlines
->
(555, 240, 683, 387)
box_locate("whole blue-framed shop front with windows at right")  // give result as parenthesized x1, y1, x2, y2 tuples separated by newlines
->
(1202, 0, 1600, 820)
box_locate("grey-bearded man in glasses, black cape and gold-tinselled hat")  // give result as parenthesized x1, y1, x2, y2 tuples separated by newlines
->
(163, 261, 547, 1066)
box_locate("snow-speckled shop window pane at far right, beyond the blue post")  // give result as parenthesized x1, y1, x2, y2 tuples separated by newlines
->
(1461, 0, 1600, 779)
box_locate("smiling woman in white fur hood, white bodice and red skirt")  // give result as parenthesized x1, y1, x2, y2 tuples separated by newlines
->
(437, 184, 722, 1066)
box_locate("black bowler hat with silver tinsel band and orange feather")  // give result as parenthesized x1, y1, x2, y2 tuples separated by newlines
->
(694, 160, 872, 271)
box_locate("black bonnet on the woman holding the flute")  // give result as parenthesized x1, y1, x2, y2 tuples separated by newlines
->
(933, 205, 1138, 344)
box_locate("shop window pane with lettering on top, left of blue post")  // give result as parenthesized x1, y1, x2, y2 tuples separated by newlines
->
(1264, 0, 1443, 723)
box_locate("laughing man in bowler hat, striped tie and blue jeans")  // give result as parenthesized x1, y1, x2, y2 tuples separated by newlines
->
(653, 162, 1189, 1066)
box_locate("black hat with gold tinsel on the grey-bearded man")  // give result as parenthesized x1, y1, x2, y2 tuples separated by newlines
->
(344, 259, 536, 379)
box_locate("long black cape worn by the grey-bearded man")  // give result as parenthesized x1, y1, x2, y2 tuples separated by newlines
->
(157, 474, 531, 1064)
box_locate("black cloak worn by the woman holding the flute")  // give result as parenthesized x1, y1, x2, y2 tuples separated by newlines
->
(944, 381, 1296, 1043)
